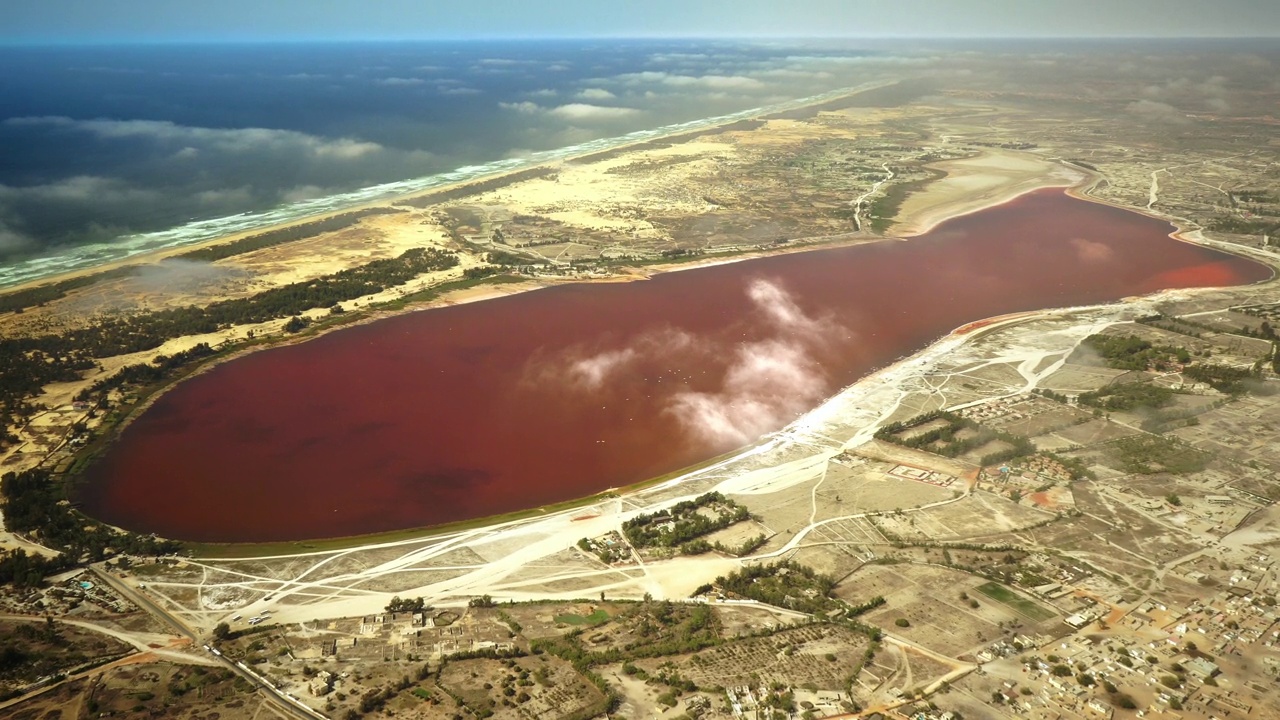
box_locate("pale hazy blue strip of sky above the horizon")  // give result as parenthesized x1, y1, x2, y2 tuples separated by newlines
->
(0, 0, 1280, 44)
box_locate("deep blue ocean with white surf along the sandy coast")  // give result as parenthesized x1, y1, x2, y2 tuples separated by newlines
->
(0, 40, 891, 287)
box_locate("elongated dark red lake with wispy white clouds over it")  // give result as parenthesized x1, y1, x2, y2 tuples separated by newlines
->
(79, 190, 1271, 542)
